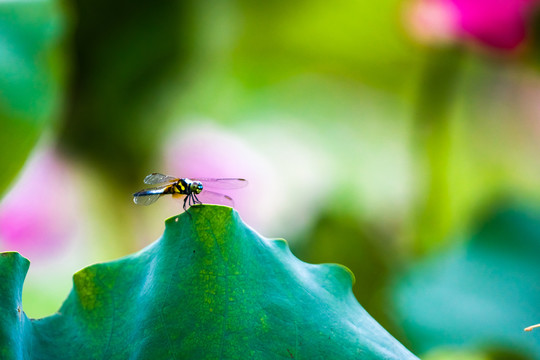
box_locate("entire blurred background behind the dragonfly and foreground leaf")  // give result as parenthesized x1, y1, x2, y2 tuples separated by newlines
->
(0, 0, 540, 360)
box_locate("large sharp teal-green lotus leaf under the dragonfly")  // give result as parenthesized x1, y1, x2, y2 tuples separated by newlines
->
(0, 206, 416, 359)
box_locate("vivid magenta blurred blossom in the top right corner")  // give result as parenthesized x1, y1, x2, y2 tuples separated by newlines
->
(406, 0, 538, 50)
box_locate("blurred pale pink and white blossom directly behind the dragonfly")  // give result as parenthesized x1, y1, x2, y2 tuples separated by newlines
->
(163, 119, 331, 238)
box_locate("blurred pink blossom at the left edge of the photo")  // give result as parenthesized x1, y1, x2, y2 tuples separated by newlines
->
(0, 149, 77, 258)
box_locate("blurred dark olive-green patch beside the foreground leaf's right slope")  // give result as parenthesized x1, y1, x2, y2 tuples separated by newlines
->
(293, 212, 403, 330)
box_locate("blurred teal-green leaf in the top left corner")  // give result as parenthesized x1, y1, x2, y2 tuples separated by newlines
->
(0, 0, 66, 194)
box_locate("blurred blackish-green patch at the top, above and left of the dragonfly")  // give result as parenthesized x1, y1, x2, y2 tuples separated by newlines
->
(60, 0, 193, 182)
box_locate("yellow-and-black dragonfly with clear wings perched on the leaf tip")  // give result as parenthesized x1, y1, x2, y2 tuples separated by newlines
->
(133, 173, 248, 210)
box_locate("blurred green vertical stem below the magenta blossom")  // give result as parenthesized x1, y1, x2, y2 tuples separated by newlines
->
(414, 48, 463, 254)
